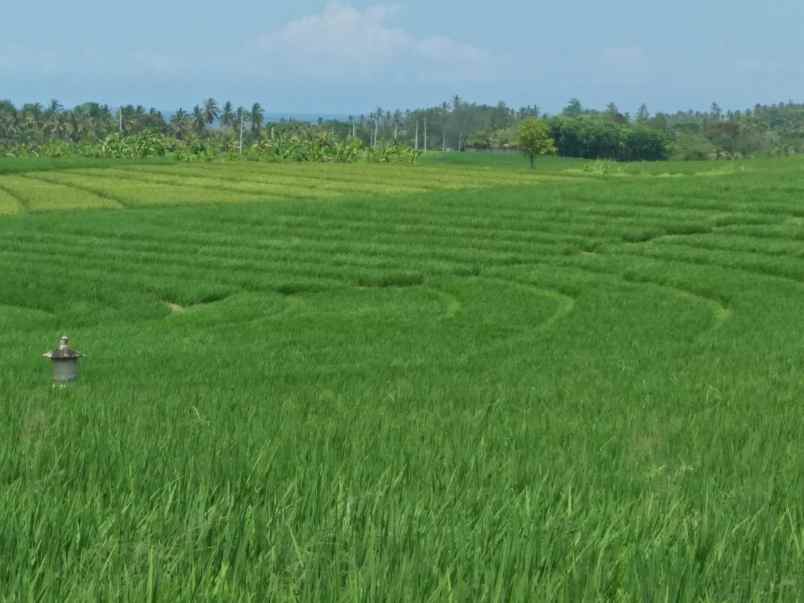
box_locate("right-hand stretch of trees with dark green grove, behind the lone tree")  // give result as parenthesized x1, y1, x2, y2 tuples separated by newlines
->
(357, 97, 804, 161)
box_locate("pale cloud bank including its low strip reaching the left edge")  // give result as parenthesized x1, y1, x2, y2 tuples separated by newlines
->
(0, 2, 499, 85)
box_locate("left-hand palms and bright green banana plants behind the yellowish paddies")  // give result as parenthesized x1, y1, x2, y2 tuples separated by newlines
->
(0, 99, 420, 163)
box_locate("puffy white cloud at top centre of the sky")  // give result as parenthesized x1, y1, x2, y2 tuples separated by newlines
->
(259, 3, 492, 79)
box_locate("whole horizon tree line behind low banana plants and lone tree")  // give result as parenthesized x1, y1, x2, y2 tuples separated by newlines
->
(0, 96, 804, 160)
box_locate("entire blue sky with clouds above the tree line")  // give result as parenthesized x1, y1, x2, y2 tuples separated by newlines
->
(0, 0, 804, 114)
